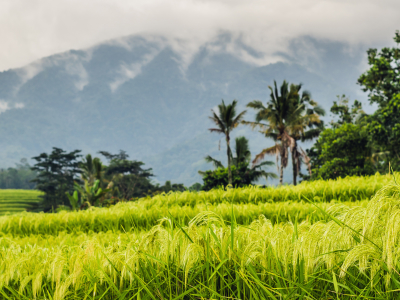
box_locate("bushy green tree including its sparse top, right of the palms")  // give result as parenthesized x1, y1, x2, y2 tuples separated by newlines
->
(302, 95, 376, 179)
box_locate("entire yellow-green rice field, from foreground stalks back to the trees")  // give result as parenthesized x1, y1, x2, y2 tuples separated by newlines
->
(0, 172, 400, 300)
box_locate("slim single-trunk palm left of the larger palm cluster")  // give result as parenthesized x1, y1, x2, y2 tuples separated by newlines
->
(209, 100, 246, 185)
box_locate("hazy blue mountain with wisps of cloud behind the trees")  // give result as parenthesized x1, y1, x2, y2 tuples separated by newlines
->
(0, 32, 372, 185)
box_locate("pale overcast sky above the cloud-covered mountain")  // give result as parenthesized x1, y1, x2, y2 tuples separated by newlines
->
(0, 0, 400, 71)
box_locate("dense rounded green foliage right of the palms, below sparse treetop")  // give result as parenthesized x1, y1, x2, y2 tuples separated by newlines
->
(308, 123, 376, 179)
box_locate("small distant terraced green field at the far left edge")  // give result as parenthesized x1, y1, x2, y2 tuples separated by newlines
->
(0, 189, 42, 215)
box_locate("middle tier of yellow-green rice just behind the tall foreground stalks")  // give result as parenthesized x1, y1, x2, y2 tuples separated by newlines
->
(0, 201, 368, 236)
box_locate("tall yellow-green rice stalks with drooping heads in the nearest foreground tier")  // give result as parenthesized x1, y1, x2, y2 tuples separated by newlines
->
(0, 185, 400, 300)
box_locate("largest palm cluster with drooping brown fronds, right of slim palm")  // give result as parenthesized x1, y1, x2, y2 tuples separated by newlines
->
(243, 81, 324, 184)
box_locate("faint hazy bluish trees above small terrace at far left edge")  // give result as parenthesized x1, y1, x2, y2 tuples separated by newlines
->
(0, 158, 37, 190)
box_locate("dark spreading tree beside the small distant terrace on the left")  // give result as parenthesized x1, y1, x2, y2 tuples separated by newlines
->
(31, 147, 81, 210)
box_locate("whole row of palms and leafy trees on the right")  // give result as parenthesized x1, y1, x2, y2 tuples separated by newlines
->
(201, 31, 400, 186)
